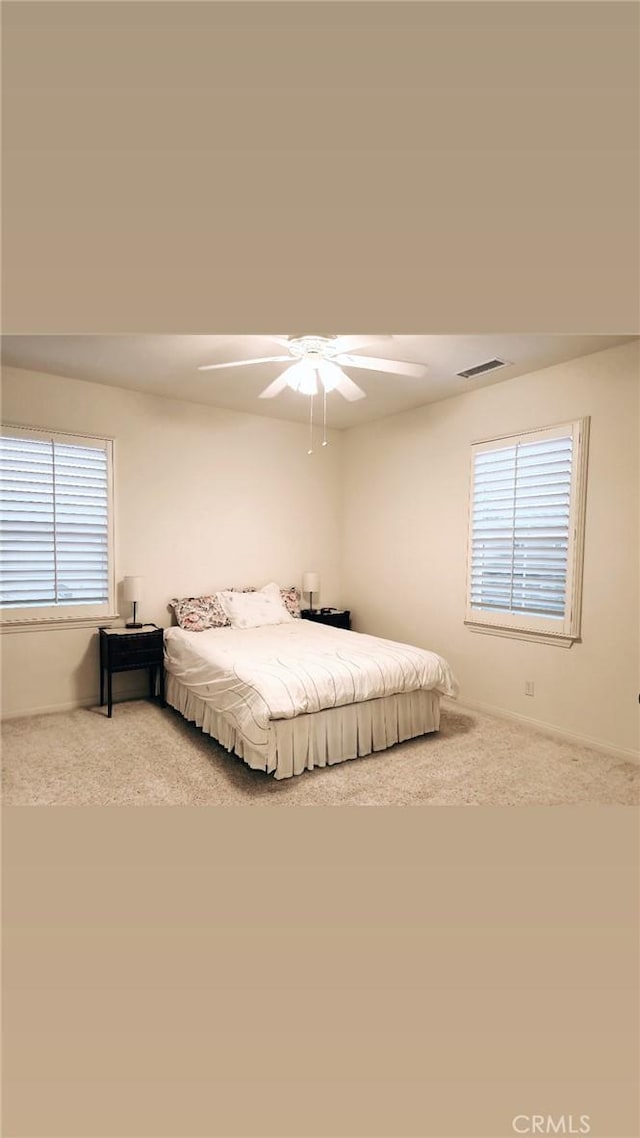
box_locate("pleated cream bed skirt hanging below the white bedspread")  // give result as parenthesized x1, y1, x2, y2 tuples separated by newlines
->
(165, 673, 440, 778)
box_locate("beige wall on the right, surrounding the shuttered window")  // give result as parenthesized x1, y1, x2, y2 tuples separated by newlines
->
(343, 343, 640, 750)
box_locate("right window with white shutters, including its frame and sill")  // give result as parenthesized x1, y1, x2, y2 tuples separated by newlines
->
(466, 419, 589, 646)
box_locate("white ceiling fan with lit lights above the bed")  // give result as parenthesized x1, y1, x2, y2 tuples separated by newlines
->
(198, 336, 426, 402)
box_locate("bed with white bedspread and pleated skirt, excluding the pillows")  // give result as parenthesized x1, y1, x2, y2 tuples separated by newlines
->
(164, 619, 457, 778)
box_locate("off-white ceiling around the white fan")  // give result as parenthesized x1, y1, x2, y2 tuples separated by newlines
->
(1, 329, 637, 428)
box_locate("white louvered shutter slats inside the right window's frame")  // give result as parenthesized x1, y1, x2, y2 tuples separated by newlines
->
(469, 434, 573, 620)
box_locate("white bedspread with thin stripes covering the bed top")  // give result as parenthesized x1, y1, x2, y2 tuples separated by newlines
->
(164, 620, 457, 747)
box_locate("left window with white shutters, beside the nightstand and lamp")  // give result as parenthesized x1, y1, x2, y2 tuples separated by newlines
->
(0, 427, 114, 626)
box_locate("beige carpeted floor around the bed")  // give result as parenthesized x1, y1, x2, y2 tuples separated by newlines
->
(2, 700, 640, 806)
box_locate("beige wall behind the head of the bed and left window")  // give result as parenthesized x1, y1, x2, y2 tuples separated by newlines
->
(1, 369, 343, 715)
